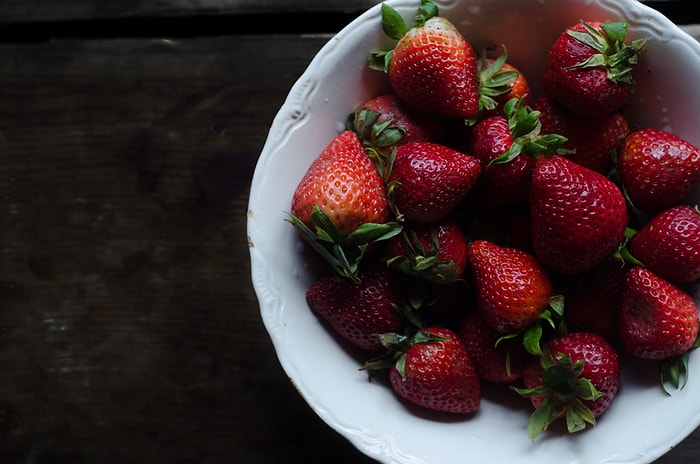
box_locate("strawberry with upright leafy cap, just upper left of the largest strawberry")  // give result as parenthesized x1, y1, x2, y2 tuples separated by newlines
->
(467, 99, 566, 209)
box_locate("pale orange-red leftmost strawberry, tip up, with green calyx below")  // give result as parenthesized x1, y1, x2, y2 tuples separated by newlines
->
(288, 130, 401, 281)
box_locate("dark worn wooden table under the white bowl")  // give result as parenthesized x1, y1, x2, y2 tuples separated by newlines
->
(0, 0, 700, 464)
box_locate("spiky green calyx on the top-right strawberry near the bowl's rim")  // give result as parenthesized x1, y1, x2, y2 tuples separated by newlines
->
(567, 21, 646, 86)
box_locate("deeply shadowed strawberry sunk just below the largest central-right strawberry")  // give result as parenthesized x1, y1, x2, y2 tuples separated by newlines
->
(564, 259, 627, 342)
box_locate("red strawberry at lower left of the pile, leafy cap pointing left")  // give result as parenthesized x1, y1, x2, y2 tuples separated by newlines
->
(363, 326, 481, 414)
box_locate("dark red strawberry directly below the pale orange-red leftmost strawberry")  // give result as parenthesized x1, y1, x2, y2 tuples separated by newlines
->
(306, 268, 405, 352)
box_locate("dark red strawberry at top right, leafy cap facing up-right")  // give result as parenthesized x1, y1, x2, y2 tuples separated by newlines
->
(542, 21, 646, 117)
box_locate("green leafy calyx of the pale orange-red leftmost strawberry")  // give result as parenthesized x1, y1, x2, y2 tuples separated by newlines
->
(286, 205, 402, 282)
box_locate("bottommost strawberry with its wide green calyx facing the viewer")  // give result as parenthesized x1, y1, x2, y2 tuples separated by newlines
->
(516, 332, 620, 441)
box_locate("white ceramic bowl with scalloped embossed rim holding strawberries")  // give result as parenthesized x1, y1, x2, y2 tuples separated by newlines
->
(248, 0, 700, 464)
